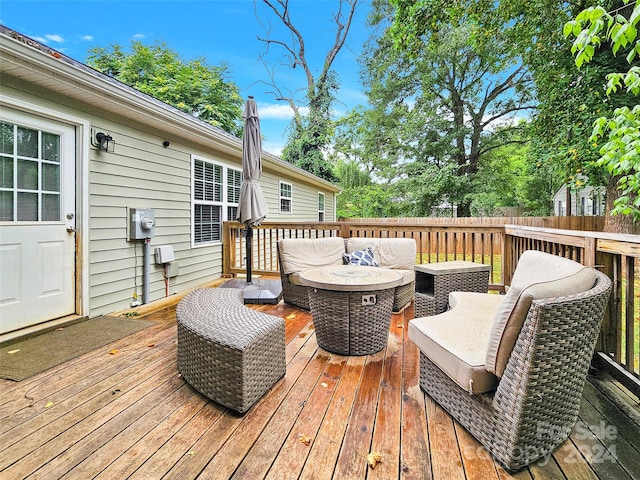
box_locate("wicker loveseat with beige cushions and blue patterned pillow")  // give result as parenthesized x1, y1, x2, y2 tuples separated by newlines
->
(277, 237, 416, 312)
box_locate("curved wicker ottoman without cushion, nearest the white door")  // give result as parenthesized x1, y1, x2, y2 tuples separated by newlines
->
(177, 288, 286, 413)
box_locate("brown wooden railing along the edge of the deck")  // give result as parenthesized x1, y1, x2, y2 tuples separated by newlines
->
(223, 221, 640, 397)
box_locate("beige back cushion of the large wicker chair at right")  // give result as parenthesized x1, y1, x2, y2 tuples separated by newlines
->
(486, 250, 596, 377)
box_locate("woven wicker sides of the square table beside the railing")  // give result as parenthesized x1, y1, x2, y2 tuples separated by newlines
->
(415, 271, 489, 318)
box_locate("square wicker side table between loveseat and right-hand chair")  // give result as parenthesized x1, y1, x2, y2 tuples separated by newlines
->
(415, 260, 491, 318)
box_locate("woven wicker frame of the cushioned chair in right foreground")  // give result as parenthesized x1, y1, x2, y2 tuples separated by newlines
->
(420, 272, 611, 470)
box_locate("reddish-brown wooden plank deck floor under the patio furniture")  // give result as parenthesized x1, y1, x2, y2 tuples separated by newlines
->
(0, 303, 640, 480)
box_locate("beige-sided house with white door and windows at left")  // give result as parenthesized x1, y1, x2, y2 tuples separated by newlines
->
(0, 26, 339, 334)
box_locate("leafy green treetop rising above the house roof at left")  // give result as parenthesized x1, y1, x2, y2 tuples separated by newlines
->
(87, 41, 243, 136)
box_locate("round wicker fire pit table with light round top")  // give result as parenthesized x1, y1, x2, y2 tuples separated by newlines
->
(300, 265, 402, 355)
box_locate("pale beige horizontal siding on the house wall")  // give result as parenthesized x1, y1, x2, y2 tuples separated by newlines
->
(2, 52, 335, 317)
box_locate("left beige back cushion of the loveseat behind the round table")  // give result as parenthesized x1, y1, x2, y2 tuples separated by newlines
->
(280, 237, 344, 275)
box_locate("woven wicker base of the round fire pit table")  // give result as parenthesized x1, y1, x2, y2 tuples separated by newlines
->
(309, 288, 394, 355)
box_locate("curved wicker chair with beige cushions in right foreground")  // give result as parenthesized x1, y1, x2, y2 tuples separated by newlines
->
(408, 251, 611, 470)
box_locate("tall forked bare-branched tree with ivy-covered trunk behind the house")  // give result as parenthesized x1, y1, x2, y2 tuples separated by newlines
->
(258, 0, 360, 181)
